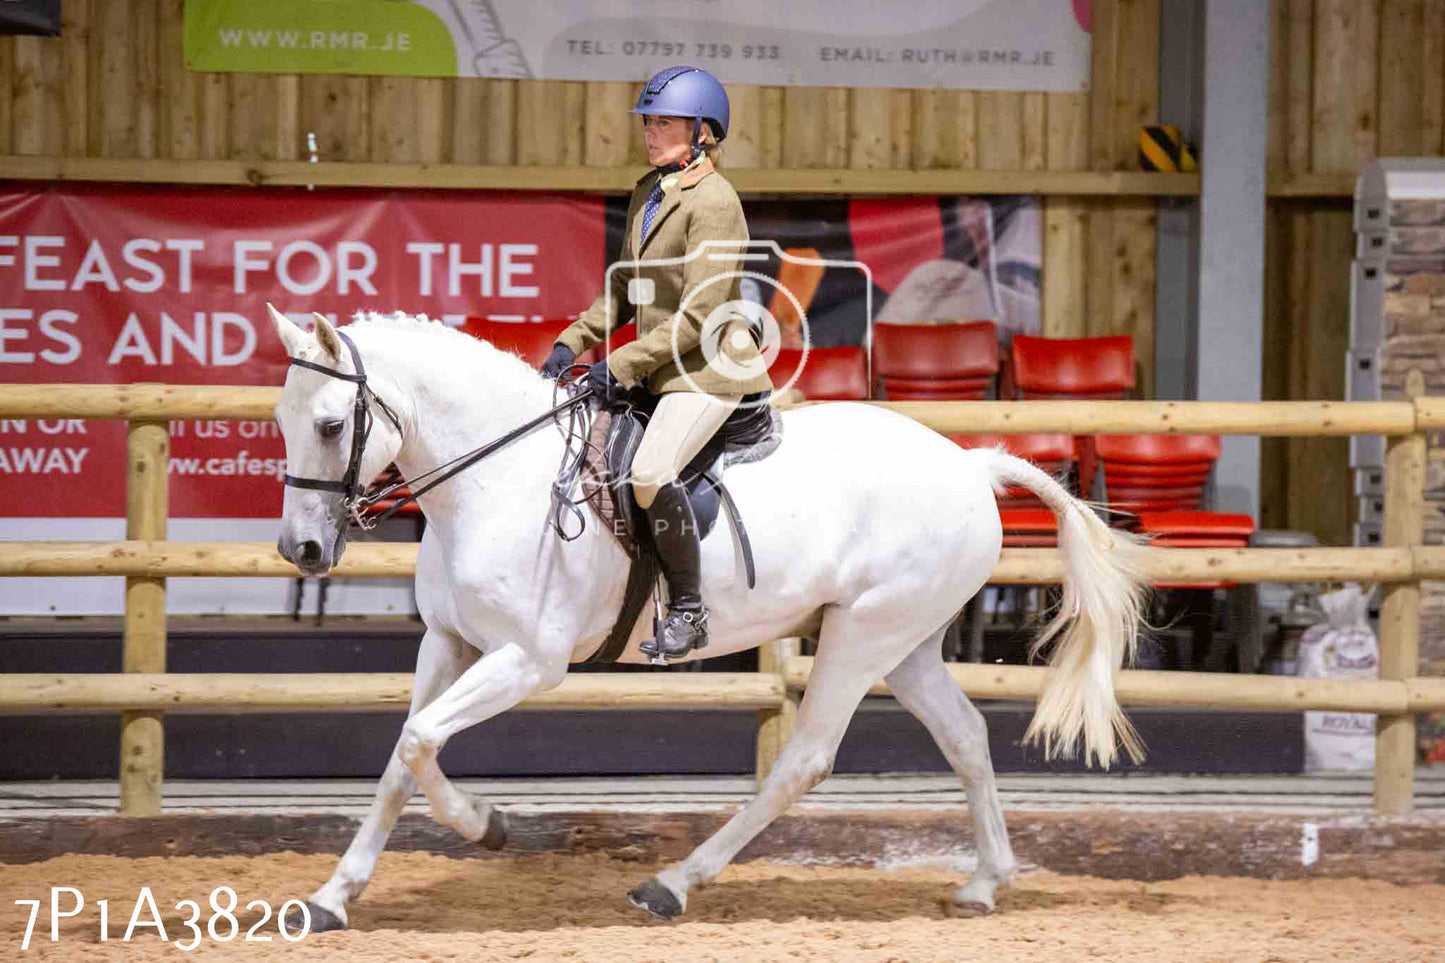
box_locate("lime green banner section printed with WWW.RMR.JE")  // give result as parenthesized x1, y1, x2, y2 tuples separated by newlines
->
(185, 0, 457, 77)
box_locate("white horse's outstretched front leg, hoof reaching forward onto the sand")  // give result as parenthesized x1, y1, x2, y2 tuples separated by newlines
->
(288, 629, 480, 933)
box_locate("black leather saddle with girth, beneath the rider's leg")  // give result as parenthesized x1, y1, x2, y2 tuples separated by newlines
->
(582, 386, 783, 664)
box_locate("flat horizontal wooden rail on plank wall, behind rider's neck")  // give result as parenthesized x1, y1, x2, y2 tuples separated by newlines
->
(0, 155, 1199, 197)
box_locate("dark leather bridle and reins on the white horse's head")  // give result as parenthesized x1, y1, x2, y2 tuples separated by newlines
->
(285, 331, 592, 529)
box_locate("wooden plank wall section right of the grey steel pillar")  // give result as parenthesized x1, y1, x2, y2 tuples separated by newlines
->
(1261, 0, 1445, 544)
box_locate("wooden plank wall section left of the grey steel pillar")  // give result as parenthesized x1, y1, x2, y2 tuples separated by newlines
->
(0, 0, 1160, 381)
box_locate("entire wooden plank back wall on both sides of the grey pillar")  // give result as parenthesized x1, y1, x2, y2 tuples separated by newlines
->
(0, 0, 1445, 544)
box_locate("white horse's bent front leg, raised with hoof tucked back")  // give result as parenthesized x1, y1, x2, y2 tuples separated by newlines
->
(396, 643, 566, 842)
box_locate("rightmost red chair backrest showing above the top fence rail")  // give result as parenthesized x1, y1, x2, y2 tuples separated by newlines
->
(1009, 334, 1136, 496)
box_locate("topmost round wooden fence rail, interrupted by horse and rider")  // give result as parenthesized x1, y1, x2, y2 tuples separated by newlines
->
(0, 383, 1421, 437)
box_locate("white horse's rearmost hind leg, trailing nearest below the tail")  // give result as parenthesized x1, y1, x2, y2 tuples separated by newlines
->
(887, 638, 1017, 915)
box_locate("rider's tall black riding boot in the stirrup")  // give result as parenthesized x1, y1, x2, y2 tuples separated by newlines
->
(642, 482, 708, 659)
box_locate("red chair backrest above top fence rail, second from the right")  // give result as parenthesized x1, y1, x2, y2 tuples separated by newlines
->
(873, 321, 998, 401)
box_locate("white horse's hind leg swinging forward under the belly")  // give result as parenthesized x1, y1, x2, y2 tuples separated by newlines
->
(627, 607, 924, 920)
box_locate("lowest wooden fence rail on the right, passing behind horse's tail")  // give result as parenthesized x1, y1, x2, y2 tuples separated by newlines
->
(783, 655, 1445, 714)
